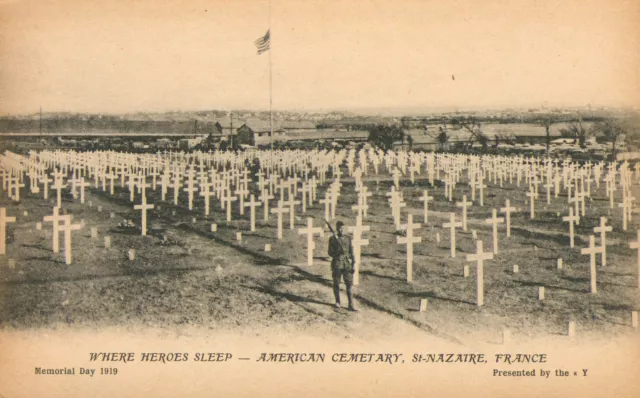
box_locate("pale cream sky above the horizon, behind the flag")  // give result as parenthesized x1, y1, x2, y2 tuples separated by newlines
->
(0, 0, 640, 115)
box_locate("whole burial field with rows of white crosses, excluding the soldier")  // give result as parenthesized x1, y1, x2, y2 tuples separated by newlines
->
(0, 149, 640, 341)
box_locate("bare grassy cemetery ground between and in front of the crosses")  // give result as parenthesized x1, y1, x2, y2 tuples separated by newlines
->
(0, 173, 640, 344)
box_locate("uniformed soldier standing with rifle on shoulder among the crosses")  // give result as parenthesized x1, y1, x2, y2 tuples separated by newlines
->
(329, 221, 358, 312)
